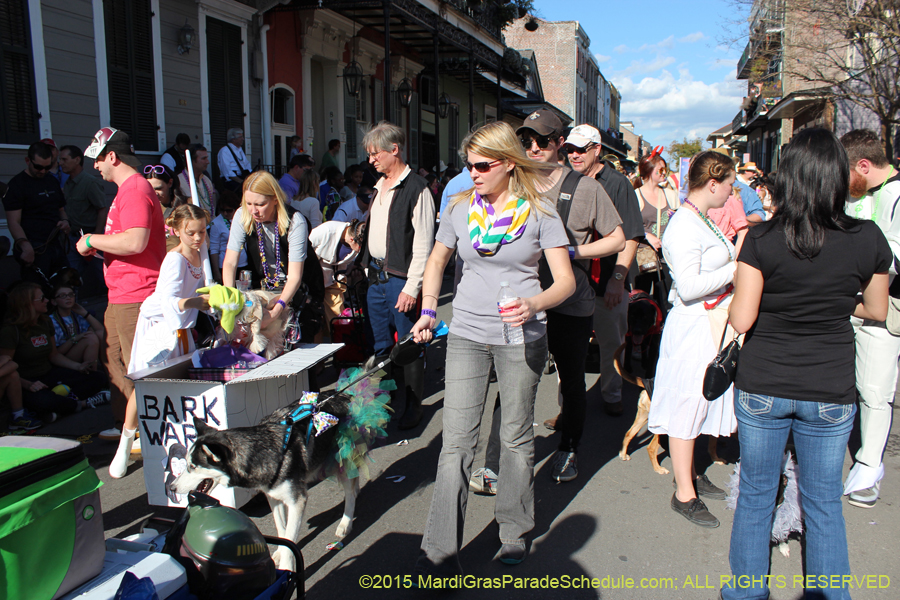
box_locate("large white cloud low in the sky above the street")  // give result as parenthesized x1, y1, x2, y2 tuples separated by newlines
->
(612, 69, 745, 144)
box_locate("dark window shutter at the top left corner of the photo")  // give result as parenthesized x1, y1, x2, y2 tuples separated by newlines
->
(0, 0, 39, 144)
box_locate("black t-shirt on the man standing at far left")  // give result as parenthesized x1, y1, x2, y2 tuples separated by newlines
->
(3, 171, 66, 245)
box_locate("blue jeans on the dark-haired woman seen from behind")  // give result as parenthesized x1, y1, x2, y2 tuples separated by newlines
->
(722, 390, 856, 600)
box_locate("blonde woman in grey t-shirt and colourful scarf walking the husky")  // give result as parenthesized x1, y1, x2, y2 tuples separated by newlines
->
(412, 123, 575, 576)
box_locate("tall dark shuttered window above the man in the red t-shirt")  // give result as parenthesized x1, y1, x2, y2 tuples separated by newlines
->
(103, 0, 159, 151)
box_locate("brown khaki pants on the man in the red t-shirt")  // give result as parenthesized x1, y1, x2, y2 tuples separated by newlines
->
(100, 302, 141, 428)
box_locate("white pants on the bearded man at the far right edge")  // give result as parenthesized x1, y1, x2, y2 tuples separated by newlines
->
(851, 318, 900, 469)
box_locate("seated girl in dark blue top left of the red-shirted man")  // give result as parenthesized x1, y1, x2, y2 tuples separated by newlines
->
(50, 286, 104, 371)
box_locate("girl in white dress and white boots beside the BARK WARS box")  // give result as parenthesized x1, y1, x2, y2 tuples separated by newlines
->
(109, 204, 209, 479)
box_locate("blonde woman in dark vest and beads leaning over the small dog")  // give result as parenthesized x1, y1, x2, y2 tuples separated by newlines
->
(222, 171, 309, 319)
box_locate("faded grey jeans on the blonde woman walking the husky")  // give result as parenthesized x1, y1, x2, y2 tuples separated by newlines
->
(416, 333, 547, 576)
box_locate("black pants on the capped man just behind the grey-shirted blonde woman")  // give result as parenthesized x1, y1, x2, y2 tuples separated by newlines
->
(547, 311, 593, 452)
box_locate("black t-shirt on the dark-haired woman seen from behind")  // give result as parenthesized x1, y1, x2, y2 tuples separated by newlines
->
(735, 219, 893, 404)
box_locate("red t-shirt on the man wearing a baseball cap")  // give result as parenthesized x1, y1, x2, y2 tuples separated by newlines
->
(104, 174, 166, 304)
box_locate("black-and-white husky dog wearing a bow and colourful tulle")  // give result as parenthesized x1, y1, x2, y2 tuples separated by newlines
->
(169, 392, 359, 570)
